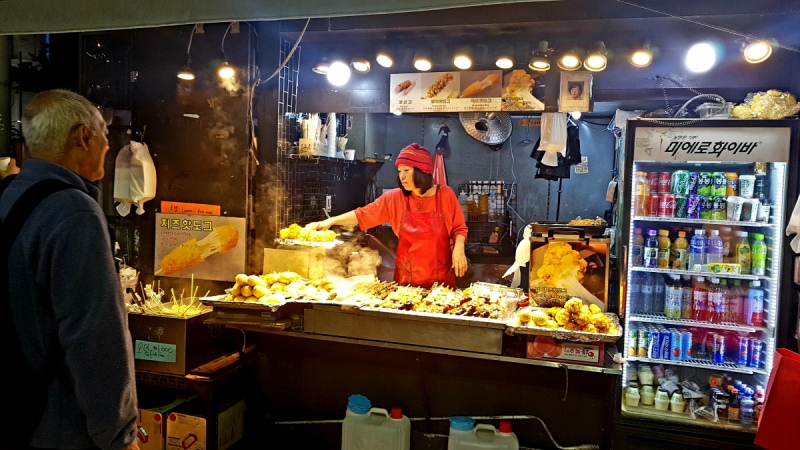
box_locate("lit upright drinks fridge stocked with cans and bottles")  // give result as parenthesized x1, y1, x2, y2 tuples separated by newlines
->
(620, 120, 794, 432)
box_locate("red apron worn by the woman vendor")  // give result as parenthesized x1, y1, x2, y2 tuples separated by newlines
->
(394, 187, 456, 289)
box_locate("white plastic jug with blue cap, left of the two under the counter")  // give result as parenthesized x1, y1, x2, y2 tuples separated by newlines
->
(342, 395, 411, 450)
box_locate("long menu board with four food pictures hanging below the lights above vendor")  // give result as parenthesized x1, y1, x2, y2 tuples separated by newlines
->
(389, 70, 544, 113)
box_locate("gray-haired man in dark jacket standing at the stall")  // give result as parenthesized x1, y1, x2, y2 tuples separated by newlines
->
(0, 90, 138, 450)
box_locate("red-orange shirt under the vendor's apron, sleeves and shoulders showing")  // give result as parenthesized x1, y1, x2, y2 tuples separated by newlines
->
(356, 186, 468, 241)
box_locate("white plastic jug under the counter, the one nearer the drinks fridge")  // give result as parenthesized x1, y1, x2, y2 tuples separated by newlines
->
(447, 416, 519, 450)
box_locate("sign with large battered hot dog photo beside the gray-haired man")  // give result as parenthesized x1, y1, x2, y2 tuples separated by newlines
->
(154, 213, 245, 281)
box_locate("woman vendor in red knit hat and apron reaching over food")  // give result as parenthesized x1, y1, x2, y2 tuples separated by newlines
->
(310, 144, 467, 289)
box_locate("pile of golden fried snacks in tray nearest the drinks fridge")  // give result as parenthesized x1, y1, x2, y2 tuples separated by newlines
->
(511, 297, 618, 334)
